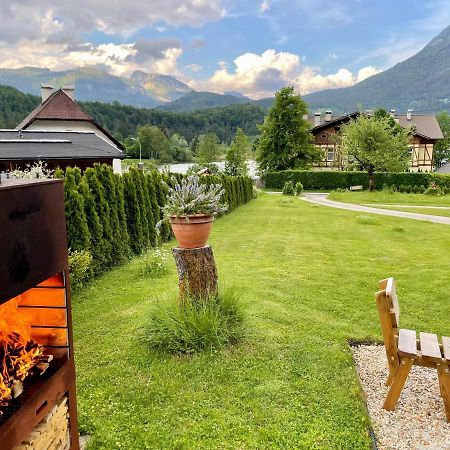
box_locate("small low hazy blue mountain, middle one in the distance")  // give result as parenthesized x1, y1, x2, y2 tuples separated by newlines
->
(158, 91, 254, 112)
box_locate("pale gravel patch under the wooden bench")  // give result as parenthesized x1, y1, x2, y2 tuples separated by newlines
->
(352, 345, 450, 450)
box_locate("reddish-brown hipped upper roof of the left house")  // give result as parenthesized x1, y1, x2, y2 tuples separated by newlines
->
(16, 89, 124, 150)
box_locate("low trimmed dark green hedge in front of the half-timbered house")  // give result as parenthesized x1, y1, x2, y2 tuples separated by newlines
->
(263, 170, 450, 189)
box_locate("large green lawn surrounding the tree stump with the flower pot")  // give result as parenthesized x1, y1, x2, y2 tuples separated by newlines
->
(73, 194, 450, 450)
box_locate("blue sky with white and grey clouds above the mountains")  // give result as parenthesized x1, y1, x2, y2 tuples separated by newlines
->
(0, 0, 450, 98)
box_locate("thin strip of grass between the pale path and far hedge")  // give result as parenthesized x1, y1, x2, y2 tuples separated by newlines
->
(328, 191, 450, 206)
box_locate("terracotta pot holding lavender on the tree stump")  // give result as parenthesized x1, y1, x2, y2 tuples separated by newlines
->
(170, 214, 214, 248)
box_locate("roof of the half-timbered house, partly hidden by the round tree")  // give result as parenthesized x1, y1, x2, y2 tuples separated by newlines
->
(308, 111, 444, 139)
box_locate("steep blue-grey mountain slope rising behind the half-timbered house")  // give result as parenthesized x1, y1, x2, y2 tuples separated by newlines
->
(303, 26, 450, 113)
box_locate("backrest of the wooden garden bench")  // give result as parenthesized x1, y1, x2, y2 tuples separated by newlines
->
(375, 278, 400, 361)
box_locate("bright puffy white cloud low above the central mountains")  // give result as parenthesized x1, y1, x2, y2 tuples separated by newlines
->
(196, 49, 378, 98)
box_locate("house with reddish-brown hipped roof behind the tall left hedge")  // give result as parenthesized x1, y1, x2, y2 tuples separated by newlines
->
(0, 86, 125, 172)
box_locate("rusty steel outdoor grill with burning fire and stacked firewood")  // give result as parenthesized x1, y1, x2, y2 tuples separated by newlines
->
(0, 180, 79, 450)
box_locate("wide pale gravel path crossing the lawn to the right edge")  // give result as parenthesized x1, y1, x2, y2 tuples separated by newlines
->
(300, 192, 450, 225)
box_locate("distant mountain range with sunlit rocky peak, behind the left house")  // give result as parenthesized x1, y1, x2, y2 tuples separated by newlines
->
(0, 67, 191, 108)
